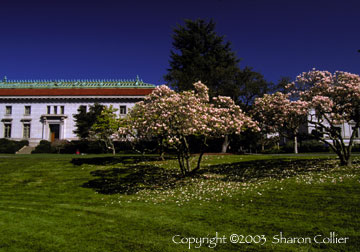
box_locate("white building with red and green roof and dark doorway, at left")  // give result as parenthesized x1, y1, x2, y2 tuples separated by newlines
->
(0, 77, 155, 146)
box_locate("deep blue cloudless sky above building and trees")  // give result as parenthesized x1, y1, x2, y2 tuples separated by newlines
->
(0, 0, 360, 84)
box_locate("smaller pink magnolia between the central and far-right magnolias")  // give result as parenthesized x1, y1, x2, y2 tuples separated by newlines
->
(253, 92, 308, 153)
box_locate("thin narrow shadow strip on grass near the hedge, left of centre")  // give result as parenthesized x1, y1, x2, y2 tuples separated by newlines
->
(71, 156, 170, 166)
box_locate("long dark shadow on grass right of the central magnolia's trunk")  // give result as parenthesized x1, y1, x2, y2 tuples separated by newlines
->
(204, 159, 337, 182)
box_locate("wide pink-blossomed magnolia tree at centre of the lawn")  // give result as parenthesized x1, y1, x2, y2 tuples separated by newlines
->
(119, 82, 258, 175)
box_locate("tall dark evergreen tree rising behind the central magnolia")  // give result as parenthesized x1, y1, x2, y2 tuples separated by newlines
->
(164, 19, 239, 97)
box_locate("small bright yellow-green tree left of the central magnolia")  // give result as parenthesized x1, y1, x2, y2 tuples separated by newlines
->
(89, 105, 120, 155)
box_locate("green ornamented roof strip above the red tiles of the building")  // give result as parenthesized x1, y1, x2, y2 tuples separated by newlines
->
(0, 76, 155, 88)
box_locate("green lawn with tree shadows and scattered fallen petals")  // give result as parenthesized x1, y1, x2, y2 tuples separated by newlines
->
(0, 155, 360, 252)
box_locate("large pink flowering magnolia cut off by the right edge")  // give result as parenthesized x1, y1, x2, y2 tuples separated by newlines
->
(294, 69, 360, 166)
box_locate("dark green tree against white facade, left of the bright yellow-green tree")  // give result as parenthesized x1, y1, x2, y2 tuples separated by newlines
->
(74, 103, 104, 139)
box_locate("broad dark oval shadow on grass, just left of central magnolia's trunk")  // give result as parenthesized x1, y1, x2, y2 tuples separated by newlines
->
(82, 165, 181, 194)
